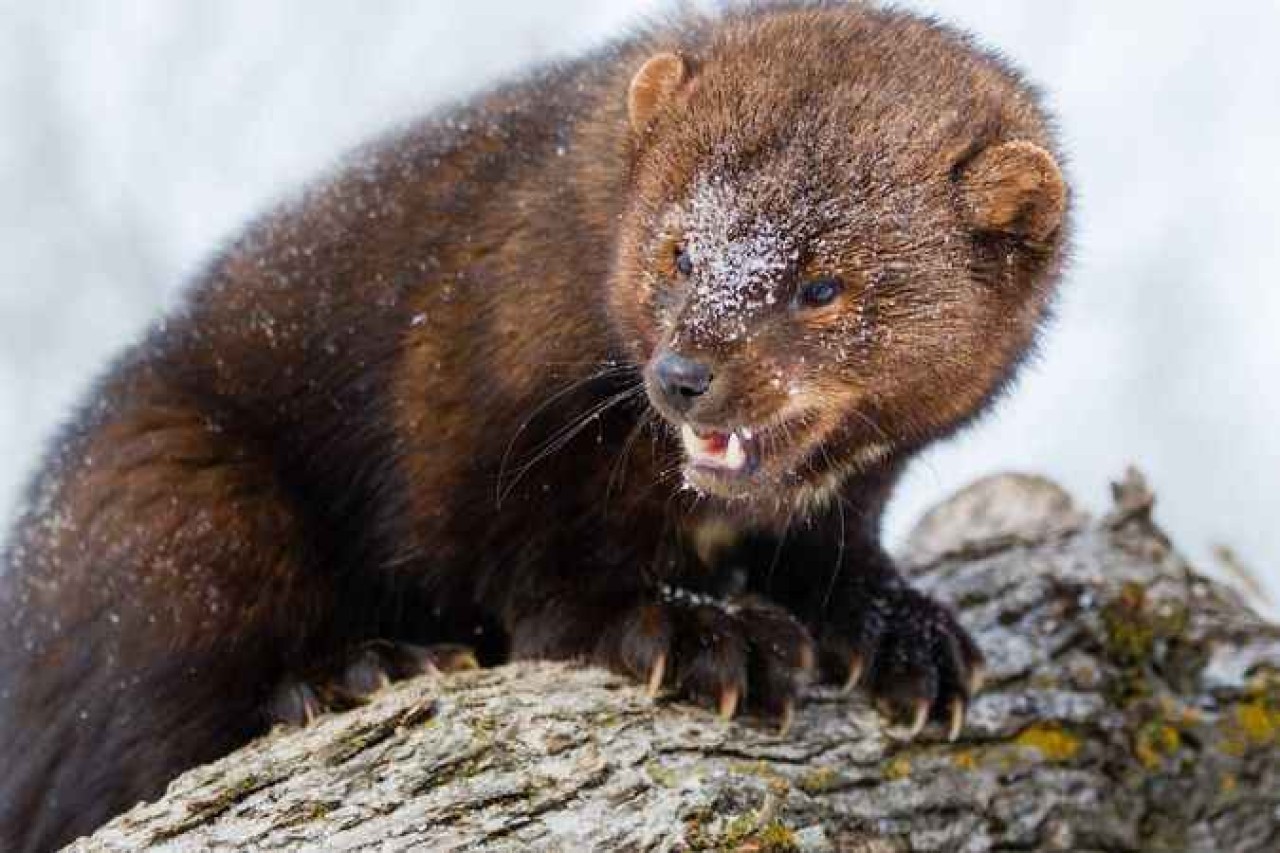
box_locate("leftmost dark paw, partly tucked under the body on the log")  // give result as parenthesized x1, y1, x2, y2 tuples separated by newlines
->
(264, 640, 479, 726)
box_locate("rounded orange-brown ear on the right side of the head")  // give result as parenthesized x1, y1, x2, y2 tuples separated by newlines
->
(956, 141, 1066, 242)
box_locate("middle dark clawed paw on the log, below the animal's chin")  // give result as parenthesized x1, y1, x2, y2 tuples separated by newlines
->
(595, 590, 814, 730)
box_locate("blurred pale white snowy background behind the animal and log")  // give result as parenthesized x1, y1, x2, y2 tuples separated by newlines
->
(0, 0, 1280, 599)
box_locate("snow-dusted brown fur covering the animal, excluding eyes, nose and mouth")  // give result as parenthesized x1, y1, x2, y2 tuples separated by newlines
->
(0, 3, 1066, 850)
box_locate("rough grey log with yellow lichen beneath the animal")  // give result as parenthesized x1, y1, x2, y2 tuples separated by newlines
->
(70, 473, 1280, 853)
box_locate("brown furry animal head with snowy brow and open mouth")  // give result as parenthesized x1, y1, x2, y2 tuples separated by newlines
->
(611, 6, 1068, 512)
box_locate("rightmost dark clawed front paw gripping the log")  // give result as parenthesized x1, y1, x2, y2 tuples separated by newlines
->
(819, 588, 983, 740)
